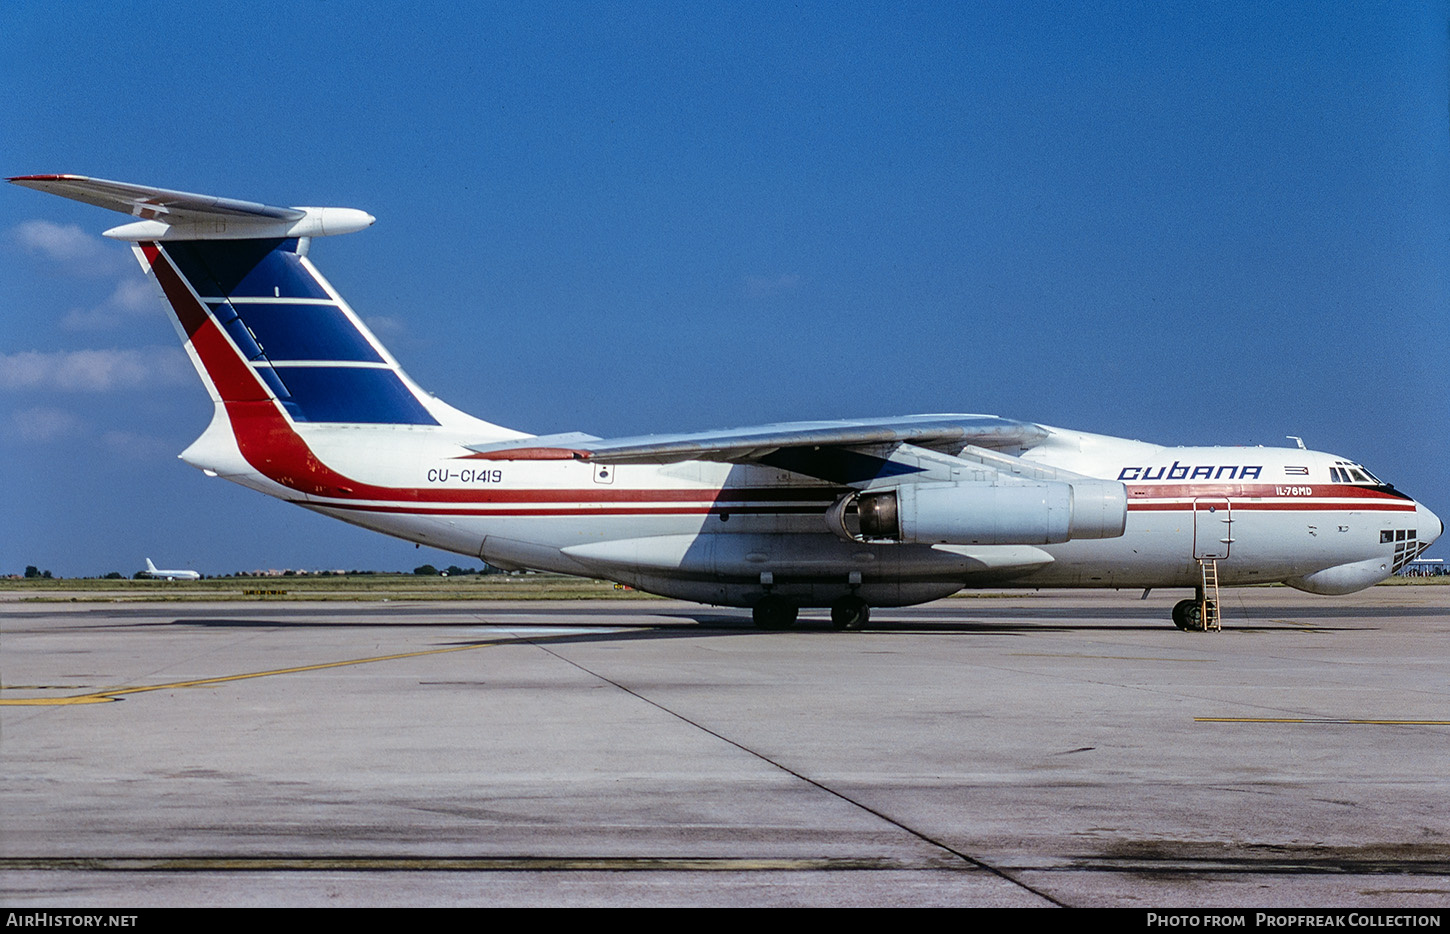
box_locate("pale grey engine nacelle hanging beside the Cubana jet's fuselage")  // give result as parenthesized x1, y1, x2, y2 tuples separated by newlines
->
(827, 480, 1128, 545)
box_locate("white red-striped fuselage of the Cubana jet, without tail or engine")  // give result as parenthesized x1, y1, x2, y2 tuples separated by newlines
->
(266, 426, 1441, 606)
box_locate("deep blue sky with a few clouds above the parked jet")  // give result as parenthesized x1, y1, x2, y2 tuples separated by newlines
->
(8, 0, 1450, 576)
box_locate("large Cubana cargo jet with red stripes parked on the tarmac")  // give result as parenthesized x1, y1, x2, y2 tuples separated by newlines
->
(10, 175, 1444, 629)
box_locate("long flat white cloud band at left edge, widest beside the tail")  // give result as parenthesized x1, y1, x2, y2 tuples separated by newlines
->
(0, 347, 193, 393)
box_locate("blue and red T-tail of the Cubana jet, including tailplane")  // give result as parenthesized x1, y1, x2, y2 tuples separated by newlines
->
(10, 175, 525, 495)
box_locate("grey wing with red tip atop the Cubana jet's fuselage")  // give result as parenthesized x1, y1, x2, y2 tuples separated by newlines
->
(468, 415, 1048, 484)
